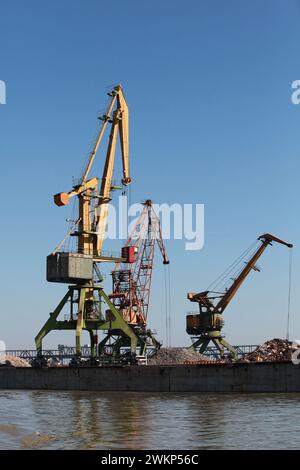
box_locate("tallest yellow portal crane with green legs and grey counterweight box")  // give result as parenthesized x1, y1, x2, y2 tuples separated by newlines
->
(35, 85, 144, 362)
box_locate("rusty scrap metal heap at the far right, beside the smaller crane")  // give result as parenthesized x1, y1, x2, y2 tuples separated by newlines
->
(241, 338, 299, 362)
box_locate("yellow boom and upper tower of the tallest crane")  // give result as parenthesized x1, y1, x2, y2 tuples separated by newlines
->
(54, 85, 131, 257)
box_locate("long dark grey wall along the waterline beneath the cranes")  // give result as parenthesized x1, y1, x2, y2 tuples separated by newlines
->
(0, 362, 300, 393)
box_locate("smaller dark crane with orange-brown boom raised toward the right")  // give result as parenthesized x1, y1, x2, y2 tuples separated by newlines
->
(186, 233, 293, 358)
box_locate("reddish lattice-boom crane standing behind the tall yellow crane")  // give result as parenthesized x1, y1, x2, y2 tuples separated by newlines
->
(99, 199, 169, 356)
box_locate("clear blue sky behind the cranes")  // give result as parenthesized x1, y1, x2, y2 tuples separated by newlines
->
(0, 0, 300, 348)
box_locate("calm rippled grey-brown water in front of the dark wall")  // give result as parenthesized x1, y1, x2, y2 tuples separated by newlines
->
(0, 390, 300, 450)
